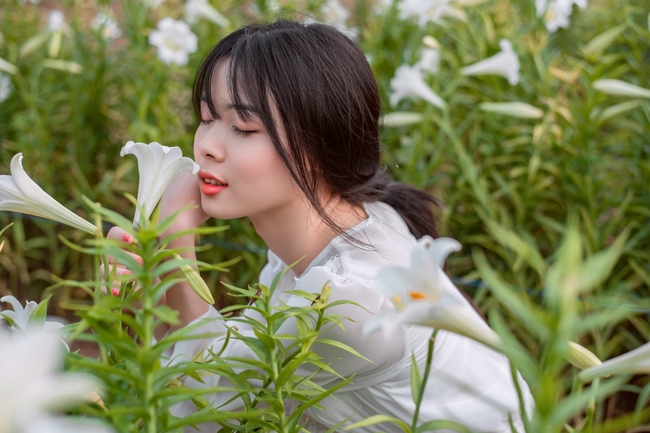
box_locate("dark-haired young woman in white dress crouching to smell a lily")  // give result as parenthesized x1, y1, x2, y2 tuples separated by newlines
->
(109, 21, 530, 432)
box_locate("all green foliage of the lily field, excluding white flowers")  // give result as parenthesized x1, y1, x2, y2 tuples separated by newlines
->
(0, 0, 650, 432)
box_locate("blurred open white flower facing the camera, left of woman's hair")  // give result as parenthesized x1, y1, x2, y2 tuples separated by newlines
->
(149, 17, 198, 66)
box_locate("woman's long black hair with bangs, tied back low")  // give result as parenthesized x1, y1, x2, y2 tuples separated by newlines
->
(193, 20, 437, 238)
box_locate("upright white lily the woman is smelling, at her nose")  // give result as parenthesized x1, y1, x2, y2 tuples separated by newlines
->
(120, 141, 199, 227)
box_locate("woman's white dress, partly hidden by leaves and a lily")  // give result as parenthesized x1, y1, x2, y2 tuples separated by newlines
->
(170, 202, 533, 433)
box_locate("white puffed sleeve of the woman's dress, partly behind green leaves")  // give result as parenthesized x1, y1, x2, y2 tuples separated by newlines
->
(163, 266, 406, 416)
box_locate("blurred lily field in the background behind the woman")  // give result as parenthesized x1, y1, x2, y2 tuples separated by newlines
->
(0, 0, 650, 416)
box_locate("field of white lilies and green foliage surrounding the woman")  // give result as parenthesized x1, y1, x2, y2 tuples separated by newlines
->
(0, 0, 650, 433)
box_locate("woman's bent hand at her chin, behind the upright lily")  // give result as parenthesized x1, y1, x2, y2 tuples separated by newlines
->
(160, 171, 209, 233)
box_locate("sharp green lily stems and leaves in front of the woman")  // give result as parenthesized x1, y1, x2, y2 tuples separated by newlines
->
(54, 202, 360, 433)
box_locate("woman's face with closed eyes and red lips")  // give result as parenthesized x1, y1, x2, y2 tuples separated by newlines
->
(194, 62, 300, 219)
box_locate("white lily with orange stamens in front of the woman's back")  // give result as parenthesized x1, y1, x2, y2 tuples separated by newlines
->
(363, 236, 502, 349)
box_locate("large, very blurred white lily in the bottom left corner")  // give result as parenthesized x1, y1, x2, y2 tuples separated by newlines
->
(0, 331, 107, 432)
